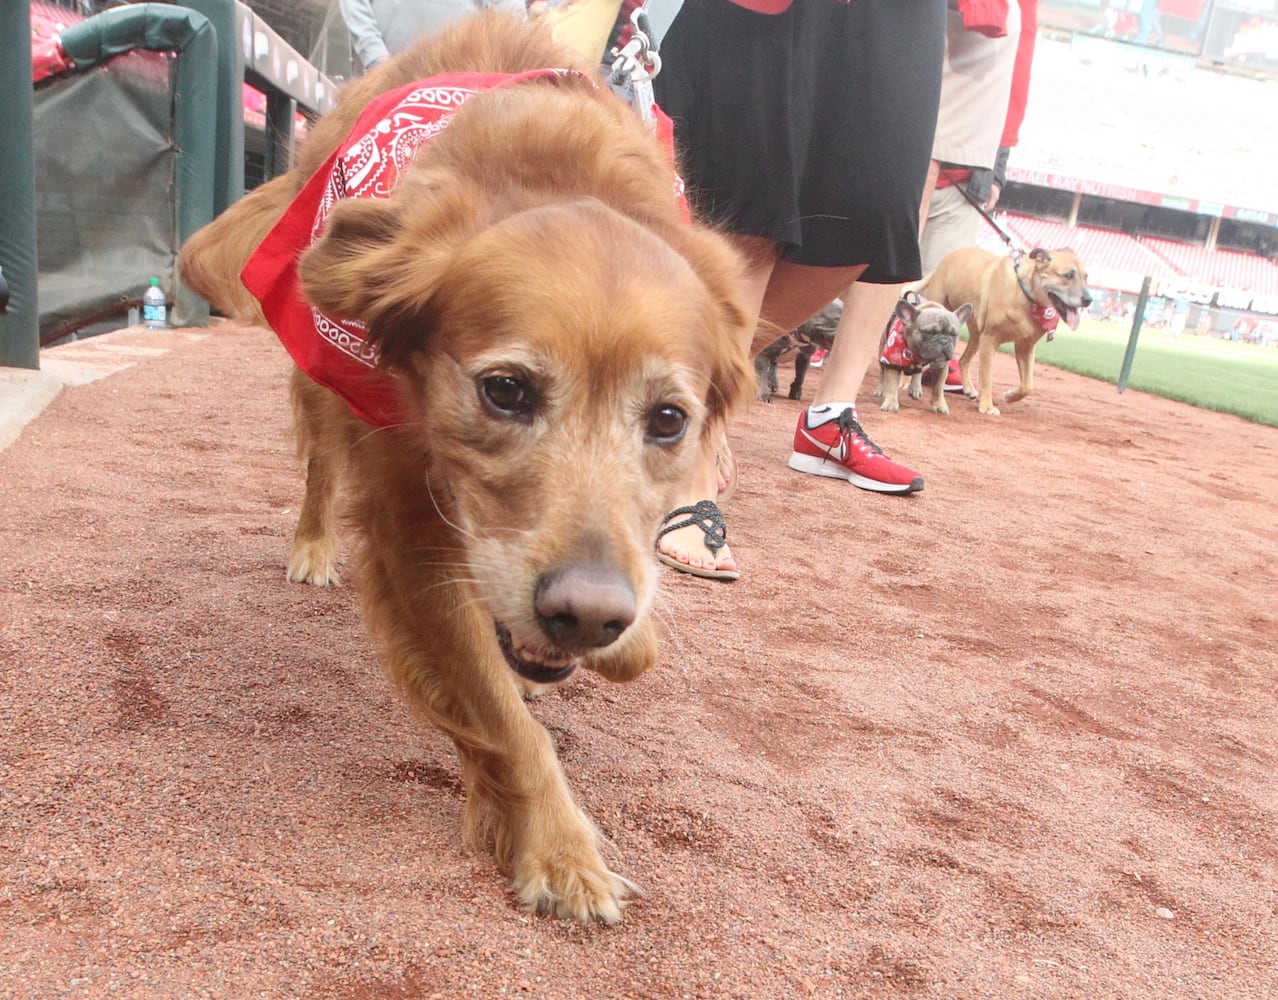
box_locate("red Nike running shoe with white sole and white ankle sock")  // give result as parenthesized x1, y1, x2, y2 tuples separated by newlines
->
(789, 407, 923, 494)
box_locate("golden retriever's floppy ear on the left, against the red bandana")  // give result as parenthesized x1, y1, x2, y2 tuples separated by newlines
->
(298, 176, 488, 367)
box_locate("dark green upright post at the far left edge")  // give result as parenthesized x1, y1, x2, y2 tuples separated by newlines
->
(0, 0, 40, 368)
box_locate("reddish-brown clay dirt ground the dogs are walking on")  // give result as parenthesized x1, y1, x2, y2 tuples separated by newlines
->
(0, 325, 1278, 1000)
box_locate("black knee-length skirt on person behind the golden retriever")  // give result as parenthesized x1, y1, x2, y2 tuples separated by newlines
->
(654, 0, 946, 284)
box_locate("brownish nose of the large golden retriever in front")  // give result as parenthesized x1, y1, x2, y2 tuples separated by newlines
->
(533, 564, 636, 648)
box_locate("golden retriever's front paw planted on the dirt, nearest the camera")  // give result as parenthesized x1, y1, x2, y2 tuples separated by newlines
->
(511, 822, 639, 923)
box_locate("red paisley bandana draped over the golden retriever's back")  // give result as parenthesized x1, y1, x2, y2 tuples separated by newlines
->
(240, 69, 688, 427)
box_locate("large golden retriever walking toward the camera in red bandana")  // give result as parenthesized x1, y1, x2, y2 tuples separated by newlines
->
(181, 14, 753, 923)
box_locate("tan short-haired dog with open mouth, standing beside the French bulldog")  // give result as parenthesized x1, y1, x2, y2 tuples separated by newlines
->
(918, 247, 1091, 417)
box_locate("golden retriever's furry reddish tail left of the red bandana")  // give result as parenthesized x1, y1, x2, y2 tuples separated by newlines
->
(178, 174, 296, 325)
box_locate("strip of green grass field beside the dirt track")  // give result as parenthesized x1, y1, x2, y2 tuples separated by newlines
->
(1007, 321, 1278, 427)
